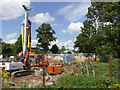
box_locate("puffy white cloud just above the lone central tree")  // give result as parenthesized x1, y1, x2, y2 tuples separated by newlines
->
(31, 13, 55, 24)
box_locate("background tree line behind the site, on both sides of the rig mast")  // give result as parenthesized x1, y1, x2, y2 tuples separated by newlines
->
(0, 23, 70, 56)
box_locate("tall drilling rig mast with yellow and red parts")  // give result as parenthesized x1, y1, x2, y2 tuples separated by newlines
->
(19, 5, 31, 68)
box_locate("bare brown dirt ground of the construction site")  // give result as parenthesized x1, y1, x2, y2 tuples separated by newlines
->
(4, 63, 80, 88)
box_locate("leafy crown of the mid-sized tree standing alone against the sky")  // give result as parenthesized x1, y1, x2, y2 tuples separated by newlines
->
(36, 23, 56, 52)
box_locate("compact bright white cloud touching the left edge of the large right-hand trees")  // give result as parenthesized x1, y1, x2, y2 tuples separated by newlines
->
(63, 22, 83, 34)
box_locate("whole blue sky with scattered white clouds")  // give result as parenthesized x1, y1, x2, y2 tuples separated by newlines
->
(0, 0, 91, 49)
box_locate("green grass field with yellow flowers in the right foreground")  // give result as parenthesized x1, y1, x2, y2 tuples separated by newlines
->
(43, 59, 120, 88)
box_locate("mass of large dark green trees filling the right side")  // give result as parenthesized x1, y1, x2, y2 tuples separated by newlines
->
(74, 2, 120, 62)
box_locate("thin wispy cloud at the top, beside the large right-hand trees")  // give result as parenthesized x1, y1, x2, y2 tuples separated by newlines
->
(57, 2, 90, 22)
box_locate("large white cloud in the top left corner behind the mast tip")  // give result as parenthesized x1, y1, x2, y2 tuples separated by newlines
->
(0, 0, 30, 20)
